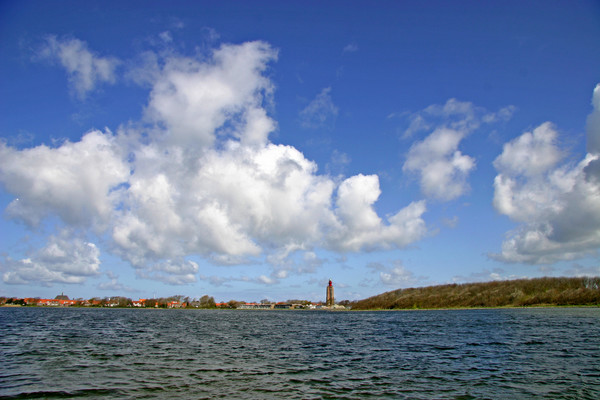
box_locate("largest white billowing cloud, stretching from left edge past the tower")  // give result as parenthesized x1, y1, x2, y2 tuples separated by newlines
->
(0, 42, 427, 284)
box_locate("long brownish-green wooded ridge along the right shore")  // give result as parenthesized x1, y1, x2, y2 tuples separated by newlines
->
(352, 278, 600, 310)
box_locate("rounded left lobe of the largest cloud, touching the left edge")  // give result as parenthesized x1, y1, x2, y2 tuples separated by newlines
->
(0, 131, 129, 226)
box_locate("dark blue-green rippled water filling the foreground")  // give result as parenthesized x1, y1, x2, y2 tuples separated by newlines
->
(0, 308, 600, 399)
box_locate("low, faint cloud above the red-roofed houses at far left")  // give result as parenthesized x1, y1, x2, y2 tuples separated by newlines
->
(2, 231, 100, 286)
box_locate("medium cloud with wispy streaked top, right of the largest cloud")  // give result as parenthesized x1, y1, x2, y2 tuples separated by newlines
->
(402, 99, 514, 201)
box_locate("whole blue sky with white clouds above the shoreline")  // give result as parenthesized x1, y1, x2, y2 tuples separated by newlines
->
(0, 0, 600, 301)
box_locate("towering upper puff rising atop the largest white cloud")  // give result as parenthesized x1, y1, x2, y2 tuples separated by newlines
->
(146, 42, 277, 149)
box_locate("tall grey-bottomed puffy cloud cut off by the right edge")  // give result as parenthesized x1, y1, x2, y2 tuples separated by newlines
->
(491, 89, 600, 264)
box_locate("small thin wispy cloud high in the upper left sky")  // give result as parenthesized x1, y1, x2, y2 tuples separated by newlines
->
(40, 36, 120, 99)
